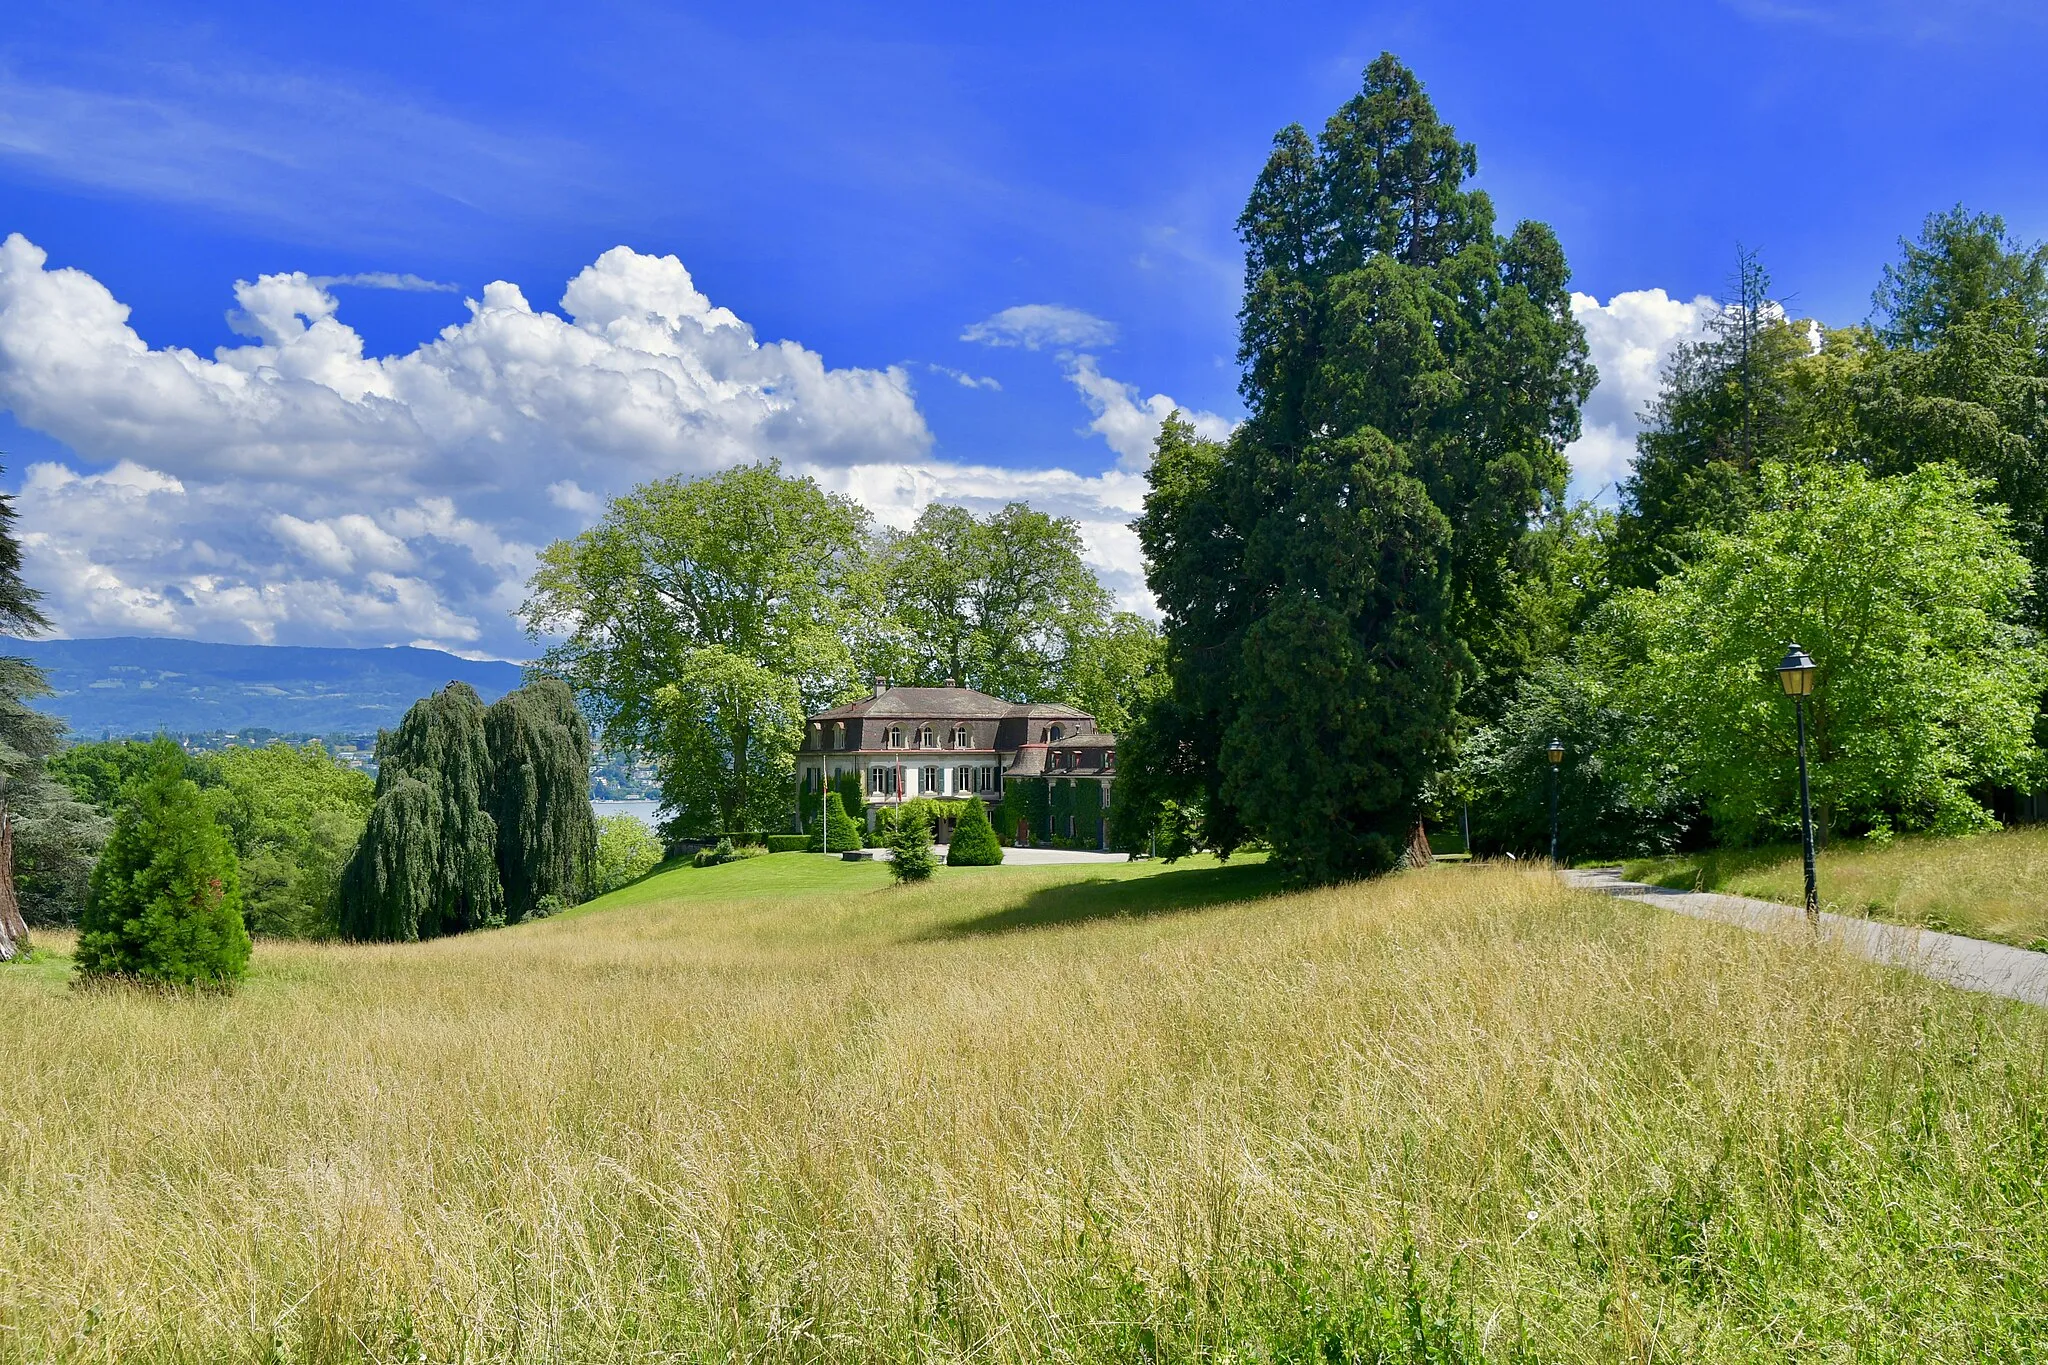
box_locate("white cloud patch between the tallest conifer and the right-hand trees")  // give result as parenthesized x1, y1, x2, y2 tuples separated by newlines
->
(1565, 289, 1716, 501)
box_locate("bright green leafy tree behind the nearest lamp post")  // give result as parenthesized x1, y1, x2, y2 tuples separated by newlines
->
(1602, 465, 2048, 841)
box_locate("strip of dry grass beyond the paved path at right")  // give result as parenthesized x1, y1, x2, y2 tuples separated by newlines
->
(1622, 829, 2048, 948)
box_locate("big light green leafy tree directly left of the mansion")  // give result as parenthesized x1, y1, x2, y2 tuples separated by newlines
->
(522, 465, 872, 833)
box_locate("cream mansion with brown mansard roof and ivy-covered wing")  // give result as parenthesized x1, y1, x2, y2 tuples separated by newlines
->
(797, 679, 1116, 847)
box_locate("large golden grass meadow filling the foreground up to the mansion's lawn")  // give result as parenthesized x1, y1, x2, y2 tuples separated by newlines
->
(0, 853, 2048, 1361)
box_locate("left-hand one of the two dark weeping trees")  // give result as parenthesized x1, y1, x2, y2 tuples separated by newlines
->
(342, 684, 504, 943)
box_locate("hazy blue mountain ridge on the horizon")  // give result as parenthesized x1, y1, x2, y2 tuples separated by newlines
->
(0, 636, 520, 739)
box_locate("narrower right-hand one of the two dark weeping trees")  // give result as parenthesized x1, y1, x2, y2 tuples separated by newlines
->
(483, 677, 598, 923)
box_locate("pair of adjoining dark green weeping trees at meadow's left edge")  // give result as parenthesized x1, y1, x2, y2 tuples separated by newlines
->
(342, 677, 598, 941)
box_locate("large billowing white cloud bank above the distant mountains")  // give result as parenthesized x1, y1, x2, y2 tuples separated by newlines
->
(0, 233, 932, 653)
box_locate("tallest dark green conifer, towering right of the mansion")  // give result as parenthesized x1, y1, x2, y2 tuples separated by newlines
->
(1126, 55, 1593, 880)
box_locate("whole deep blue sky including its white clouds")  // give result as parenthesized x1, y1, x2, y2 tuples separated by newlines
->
(0, 0, 2048, 657)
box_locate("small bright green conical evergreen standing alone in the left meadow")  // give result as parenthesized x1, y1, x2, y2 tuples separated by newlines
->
(78, 739, 250, 990)
